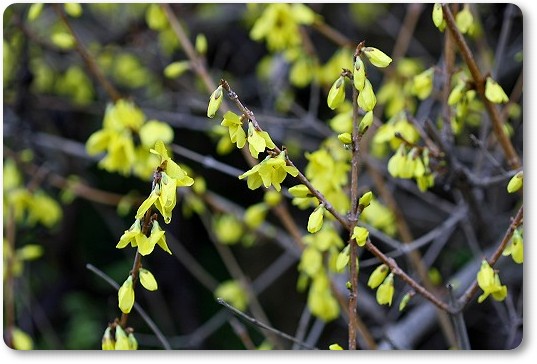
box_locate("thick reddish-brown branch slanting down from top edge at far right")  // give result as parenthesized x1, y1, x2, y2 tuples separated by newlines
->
(442, 4, 521, 169)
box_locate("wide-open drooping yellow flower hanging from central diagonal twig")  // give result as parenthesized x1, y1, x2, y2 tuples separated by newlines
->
(239, 152, 298, 191)
